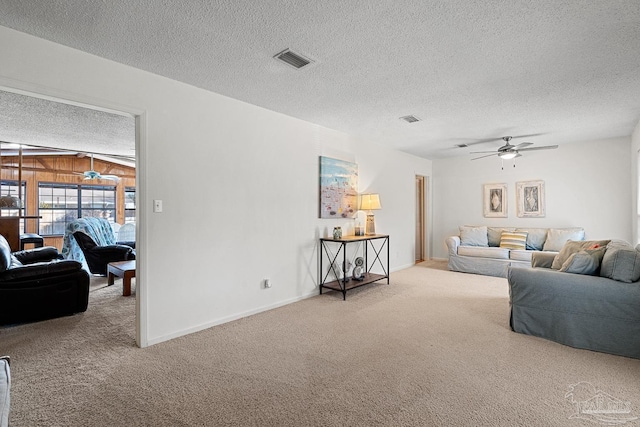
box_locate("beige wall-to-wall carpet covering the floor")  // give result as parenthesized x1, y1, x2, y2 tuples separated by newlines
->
(0, 262, 640, 427)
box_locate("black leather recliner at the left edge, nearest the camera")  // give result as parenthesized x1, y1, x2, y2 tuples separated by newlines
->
(0, 236, 89, 325)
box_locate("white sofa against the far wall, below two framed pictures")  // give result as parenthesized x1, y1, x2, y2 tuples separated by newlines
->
(446, 226, 584, 277)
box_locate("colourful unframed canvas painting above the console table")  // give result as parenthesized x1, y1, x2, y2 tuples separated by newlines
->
(320, 156, 358, 218)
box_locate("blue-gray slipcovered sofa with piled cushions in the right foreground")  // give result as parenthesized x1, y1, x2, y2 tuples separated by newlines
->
(507, 241, 640, 359)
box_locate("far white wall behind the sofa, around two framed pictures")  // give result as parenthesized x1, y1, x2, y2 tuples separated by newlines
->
(433, 137, 632, 258)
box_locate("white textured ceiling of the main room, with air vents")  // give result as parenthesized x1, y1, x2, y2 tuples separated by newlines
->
(0, 0, 640, 158)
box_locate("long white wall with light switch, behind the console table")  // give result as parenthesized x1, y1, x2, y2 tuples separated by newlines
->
(0, 27, 431, 346)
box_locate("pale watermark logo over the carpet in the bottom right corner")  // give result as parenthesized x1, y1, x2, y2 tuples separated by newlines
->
(564, 381, 638, 426)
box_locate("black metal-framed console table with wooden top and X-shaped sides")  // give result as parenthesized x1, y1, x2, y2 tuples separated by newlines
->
(319, 234, 389, 300)
